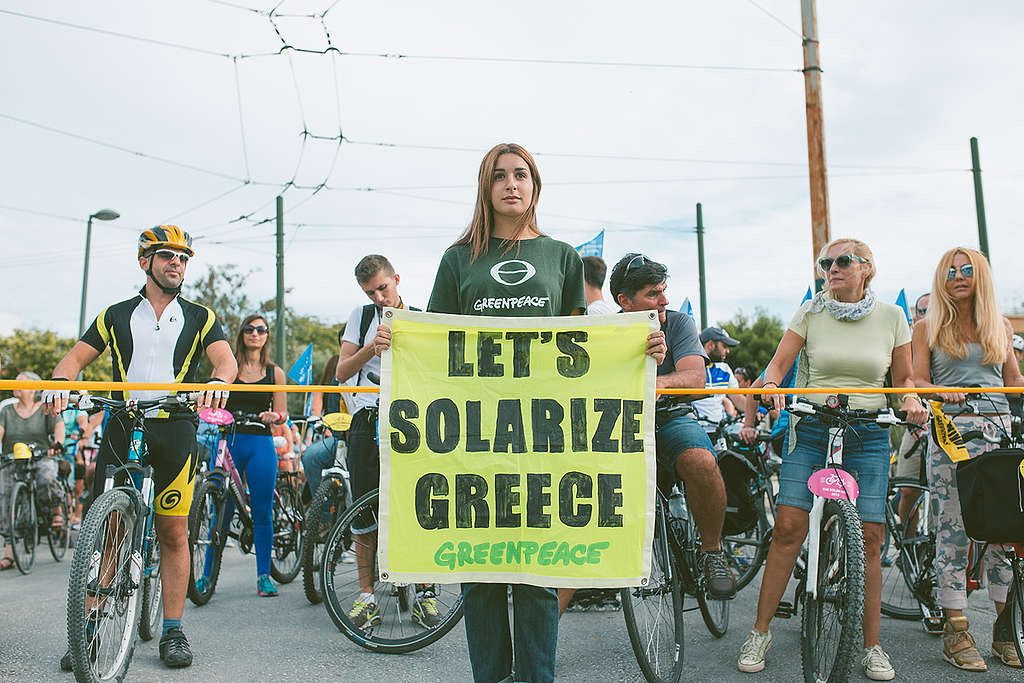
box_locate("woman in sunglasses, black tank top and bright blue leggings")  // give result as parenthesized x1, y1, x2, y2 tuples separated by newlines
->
(220, 313, 288, 598)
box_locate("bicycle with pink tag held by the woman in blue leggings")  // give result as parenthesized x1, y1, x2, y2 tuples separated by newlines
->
(187, 409, 303, 605)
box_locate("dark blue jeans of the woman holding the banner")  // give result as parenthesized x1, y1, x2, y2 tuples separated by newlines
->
(462, 584, 558, 683)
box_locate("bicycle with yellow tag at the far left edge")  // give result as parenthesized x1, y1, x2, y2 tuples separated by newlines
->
(0, 443, 72, 574)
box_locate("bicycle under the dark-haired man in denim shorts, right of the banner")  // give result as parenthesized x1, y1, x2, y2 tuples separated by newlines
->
(620, 396, 729, 683)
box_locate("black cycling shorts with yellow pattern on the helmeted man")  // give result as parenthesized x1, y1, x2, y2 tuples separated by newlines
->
(92, 417, 199, 517)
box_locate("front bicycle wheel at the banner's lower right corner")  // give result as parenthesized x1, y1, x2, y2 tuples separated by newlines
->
(620, 499, 684, 683)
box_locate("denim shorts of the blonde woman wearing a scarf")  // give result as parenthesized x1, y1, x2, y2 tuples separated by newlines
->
(776, 416, 889, 523)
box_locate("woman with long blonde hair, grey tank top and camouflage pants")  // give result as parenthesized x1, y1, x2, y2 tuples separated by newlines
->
(913, 247, 1024, 671)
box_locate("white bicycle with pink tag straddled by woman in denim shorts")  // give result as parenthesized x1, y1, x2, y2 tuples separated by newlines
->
(775, 394, 906, 683)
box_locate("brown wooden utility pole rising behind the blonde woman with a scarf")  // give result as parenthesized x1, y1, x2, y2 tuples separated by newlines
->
(800, 0, 831, 292)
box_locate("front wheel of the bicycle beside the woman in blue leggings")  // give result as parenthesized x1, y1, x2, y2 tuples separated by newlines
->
(186, 479, 228, 607)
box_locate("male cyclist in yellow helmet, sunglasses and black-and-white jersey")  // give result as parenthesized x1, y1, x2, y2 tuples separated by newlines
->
(43, 225, 238, 671)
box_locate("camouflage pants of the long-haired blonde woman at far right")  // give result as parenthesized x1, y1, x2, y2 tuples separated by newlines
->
(928, 416, 1013, 609)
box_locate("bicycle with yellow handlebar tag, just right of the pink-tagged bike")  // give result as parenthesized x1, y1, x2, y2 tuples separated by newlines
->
(302, 413, 354, 605)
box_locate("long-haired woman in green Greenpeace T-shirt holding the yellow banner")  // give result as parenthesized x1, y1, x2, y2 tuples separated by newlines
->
(375, 143, 665, 683)
